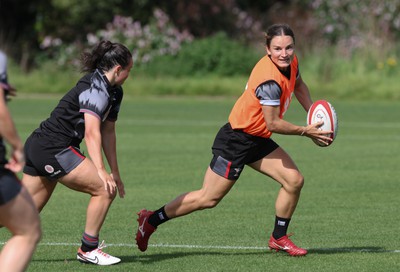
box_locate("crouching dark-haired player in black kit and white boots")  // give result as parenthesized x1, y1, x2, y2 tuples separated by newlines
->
(22, 41, 133, 265)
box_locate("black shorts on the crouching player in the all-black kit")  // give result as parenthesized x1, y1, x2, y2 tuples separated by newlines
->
(24, 132, 86, 180)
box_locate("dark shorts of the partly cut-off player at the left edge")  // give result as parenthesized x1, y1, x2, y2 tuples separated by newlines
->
(0, 169, 22, 205)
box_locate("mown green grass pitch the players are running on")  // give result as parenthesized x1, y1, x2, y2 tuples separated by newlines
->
(0, 96, 400, 272)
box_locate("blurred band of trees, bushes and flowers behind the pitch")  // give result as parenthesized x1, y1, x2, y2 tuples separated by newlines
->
(0, 0, 400, 98)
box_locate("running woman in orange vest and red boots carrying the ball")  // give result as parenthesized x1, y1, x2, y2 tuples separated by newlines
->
(136, 24, 331, 256)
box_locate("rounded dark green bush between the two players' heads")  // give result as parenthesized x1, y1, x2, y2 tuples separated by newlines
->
(141, 33, 262, 76)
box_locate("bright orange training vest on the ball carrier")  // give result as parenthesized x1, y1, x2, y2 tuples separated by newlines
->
(229, 56, 298, 138)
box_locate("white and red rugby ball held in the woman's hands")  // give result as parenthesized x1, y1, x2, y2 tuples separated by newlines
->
(307, 100, 338, 147)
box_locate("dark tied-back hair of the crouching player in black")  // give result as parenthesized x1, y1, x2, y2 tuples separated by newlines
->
(81, 41, 132, 72)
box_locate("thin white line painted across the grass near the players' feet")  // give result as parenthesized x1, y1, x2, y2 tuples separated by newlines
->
(0, 242, 400, 253)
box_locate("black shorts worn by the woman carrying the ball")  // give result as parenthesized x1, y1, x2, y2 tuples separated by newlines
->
(210, 123, 279, 180)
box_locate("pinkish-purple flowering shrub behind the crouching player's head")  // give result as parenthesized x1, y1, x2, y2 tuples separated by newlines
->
(40, 9, 193, 66)
